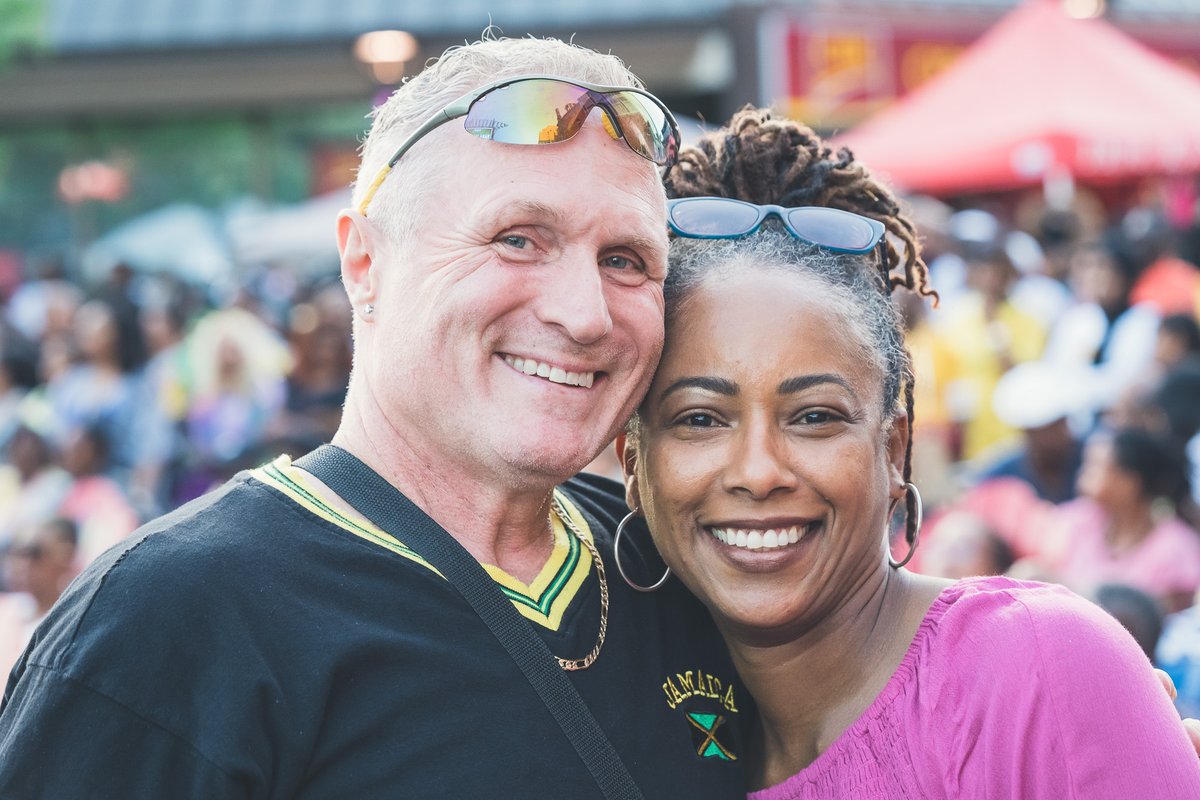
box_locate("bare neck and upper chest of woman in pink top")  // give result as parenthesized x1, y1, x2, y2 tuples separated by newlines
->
(726, 567, 949, 788)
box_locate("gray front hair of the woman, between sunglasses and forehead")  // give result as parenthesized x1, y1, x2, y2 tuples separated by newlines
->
(630, 221, 912, 422)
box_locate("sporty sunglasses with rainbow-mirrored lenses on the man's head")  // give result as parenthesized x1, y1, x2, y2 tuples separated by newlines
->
(359, 76, 679, 215)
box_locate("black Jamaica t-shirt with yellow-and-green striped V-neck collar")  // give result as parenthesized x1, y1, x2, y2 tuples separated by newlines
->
(0, 459, 749, 800)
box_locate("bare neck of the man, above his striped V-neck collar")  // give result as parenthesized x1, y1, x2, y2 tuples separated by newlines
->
(334, 417, 566, 582)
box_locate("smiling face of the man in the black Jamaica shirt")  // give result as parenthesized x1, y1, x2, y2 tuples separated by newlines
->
(358, 113, 667, 488)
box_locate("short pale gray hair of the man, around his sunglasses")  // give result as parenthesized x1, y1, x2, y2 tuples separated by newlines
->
(353, 31, 642, 240)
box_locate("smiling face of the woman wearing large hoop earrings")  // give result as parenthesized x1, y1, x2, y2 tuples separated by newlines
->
(625, 269, 907, 640)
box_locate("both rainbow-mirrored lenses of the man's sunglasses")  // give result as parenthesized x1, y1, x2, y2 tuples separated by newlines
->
(466, 78, 678, 164)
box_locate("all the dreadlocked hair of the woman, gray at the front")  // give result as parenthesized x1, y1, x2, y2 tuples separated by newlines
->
(657, 107, 937, 554)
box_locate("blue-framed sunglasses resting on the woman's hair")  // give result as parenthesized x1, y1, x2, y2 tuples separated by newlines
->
(667, 197, 886, 253)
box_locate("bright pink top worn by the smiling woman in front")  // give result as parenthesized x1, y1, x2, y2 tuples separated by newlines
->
(749, 578, 1200, 800)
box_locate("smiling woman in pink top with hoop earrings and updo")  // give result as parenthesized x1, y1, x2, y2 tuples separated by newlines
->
(618, 110, 1200, 800)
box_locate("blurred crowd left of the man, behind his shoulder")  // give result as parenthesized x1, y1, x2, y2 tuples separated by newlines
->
(0, 256, 350, 673)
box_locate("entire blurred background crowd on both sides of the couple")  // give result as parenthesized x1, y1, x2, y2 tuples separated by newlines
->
(7, 189, 1200, 716)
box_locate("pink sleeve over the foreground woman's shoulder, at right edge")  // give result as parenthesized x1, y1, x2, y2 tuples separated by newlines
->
(922, 587, 1200, 800)
